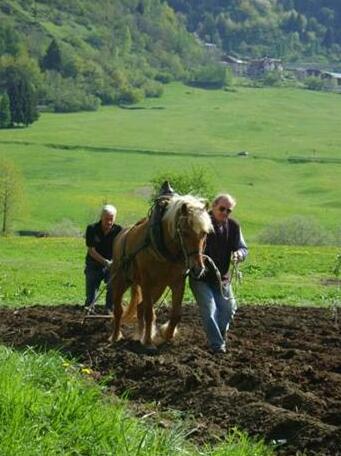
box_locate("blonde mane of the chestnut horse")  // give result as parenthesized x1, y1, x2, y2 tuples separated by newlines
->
(163, 195, 213, 235)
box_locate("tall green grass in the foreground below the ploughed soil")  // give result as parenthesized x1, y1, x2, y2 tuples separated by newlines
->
(0, 346, 272, 456)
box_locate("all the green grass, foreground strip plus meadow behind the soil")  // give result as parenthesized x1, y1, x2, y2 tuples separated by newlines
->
(0, 84, 341, 456)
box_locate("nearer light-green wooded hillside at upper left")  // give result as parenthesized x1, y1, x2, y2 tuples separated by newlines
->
(0, 0, 204, 112)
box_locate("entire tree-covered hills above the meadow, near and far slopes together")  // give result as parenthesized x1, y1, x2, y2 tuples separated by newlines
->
(0, 0, 341, 122)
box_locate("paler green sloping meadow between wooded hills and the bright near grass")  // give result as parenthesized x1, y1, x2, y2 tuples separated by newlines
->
(0, 84, 341, 240)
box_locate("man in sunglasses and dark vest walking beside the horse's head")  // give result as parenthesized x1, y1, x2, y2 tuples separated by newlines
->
(190, 194, 248, 353)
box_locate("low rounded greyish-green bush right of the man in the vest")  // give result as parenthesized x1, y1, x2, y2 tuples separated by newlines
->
(258, 215, 336, 245)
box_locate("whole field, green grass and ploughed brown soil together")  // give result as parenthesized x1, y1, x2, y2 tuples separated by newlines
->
(0, 84, 341, 456)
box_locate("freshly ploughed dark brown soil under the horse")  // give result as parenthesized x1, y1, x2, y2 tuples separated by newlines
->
(0, 305, 341, 456)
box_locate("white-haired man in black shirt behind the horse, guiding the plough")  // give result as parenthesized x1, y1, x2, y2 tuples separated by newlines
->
(84, 204, 122, 312)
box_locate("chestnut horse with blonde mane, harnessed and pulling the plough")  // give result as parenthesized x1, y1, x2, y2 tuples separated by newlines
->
(111, 195, 212, 352)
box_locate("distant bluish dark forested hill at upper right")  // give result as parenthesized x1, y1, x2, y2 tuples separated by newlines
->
(168, 0, 341, 67)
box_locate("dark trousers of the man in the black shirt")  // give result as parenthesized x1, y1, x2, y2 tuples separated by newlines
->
(84, 264, 112, 309)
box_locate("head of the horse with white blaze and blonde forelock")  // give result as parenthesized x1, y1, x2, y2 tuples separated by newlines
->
(165, 195, 213, 278)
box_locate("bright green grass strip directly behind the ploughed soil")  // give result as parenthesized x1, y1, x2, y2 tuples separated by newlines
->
(0, 237, 339, 307)
